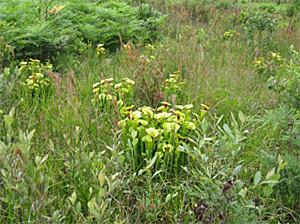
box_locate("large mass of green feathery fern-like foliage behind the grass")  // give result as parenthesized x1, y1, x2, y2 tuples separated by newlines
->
(0, 0, 163, 59)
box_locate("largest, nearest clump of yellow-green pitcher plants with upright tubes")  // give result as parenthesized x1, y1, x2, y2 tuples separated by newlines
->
(118, 102, 209, 170)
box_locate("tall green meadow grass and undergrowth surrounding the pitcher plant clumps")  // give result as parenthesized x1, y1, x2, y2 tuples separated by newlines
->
(0, 1, 300, 223)
